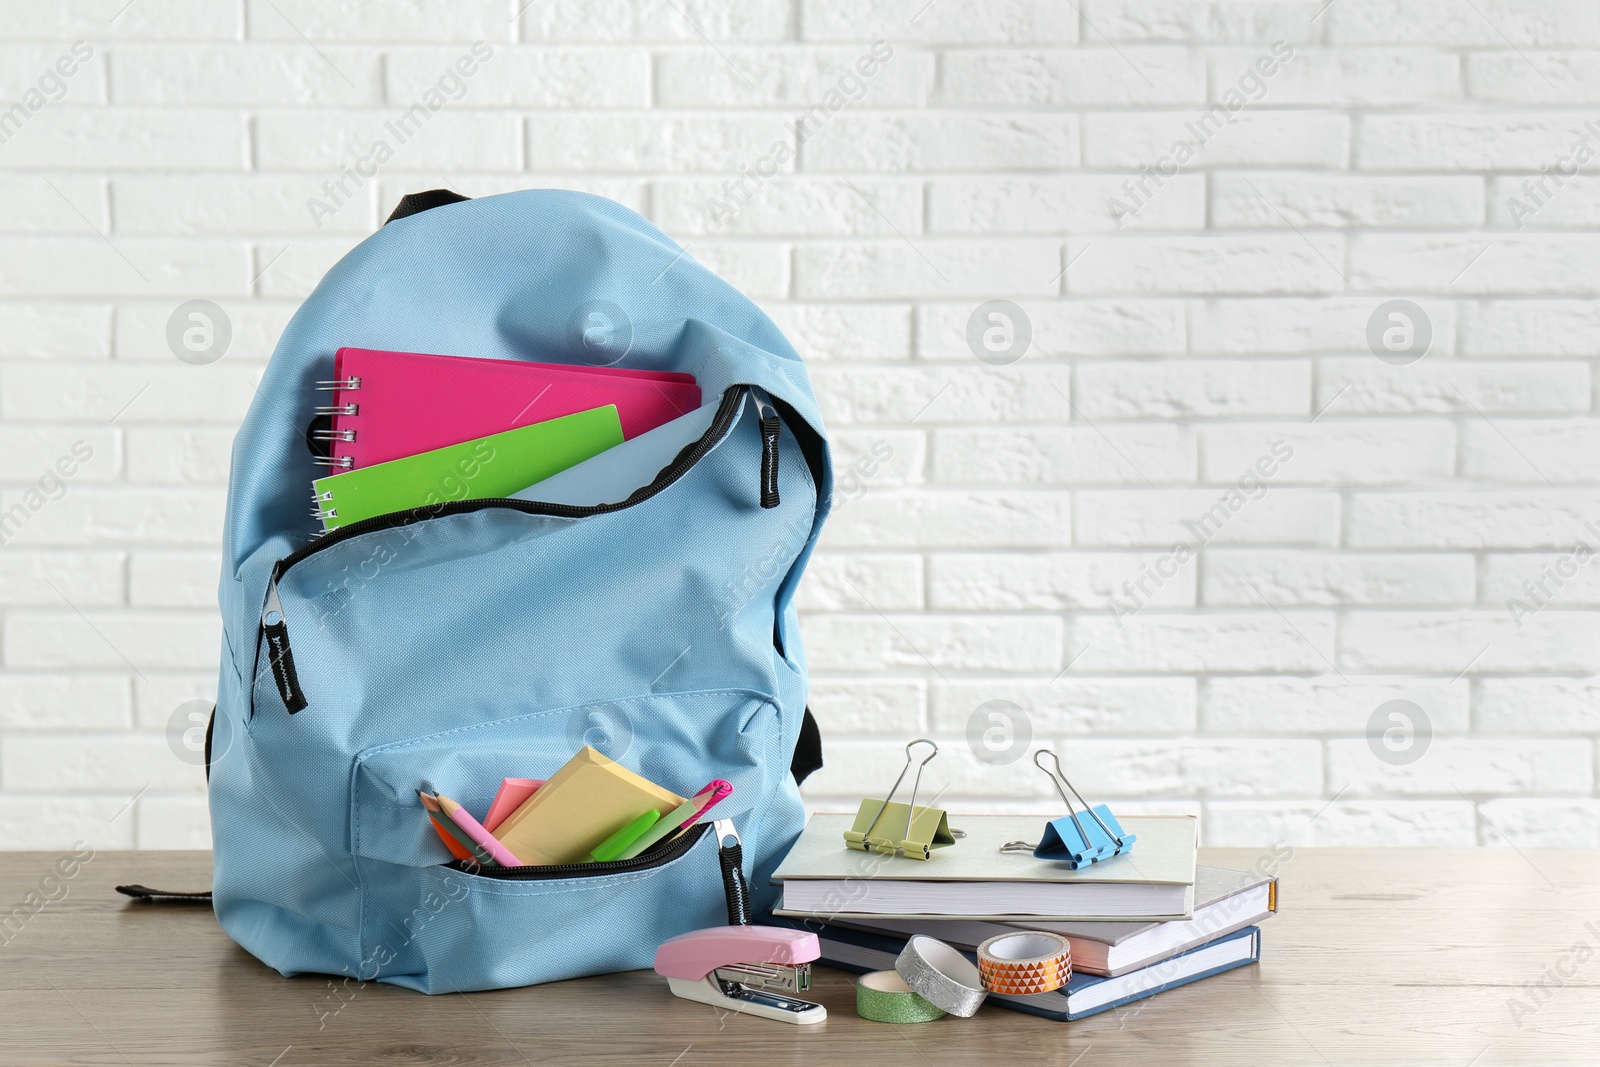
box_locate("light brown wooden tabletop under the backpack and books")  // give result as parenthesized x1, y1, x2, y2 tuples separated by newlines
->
(0, 846, 1600, 1067)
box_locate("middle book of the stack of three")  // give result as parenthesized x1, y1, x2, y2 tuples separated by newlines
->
(834, 867, 1278, 977)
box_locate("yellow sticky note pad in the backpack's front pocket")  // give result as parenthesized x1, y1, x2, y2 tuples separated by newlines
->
(494, 745, 685, 864)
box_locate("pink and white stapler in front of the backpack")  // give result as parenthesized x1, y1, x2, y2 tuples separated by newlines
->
(656, 926, 827, 1024)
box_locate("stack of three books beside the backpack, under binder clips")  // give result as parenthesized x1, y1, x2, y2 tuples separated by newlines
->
(773, 814, 1278, 1021)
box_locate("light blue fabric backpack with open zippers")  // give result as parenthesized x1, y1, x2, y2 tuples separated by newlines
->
(198, 190, 830, 993)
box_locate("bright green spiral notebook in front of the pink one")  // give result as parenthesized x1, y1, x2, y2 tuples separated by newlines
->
(312, 405, 622, 530)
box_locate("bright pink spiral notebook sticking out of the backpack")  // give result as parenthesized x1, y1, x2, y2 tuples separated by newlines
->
(331, 349, 701, 470)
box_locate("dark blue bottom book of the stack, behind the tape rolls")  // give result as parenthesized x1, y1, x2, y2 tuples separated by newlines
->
(774, 920, 1261, 1022)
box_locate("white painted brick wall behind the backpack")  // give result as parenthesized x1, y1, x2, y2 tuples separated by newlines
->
(0, 0, 1600, 848)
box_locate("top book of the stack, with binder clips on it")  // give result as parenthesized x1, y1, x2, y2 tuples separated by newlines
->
(773, 814, 1197, 921)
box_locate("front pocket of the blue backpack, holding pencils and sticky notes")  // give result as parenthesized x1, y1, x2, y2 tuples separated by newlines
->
(350, 691, 787, 992)
